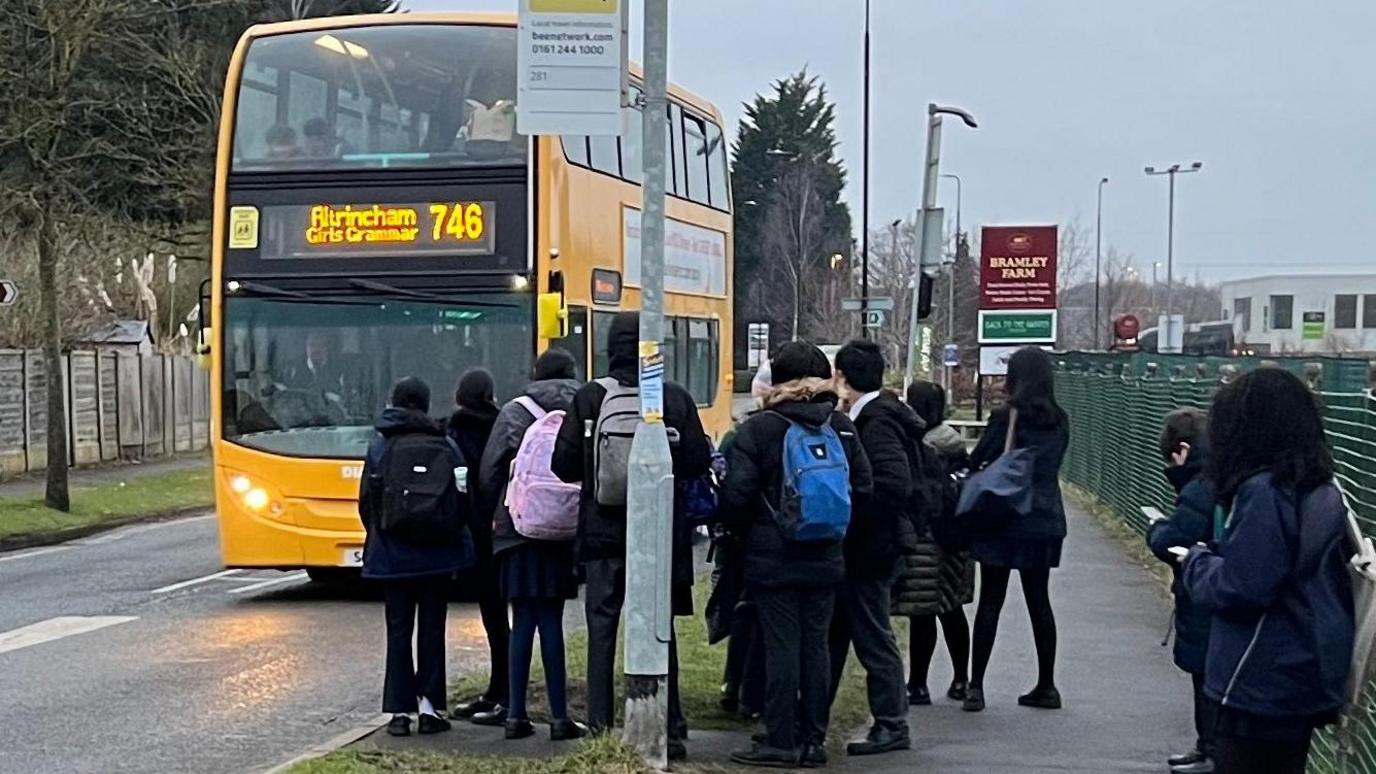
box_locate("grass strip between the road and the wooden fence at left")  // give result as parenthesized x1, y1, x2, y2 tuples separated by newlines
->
(0, 466, 213, 540)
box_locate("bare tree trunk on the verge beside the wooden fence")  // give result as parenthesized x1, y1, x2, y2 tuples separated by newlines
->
(39, 208, 72, 511)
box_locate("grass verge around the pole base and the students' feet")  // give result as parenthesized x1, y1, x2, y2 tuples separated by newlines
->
(290, 581, 875, 774)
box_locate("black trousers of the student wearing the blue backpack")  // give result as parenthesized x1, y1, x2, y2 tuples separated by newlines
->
(754, 588, 836, 751)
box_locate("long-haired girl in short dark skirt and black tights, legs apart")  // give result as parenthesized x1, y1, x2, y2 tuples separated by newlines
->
(962, 347, 1071, 712)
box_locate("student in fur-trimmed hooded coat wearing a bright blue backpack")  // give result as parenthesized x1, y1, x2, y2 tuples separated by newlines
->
(721, 342, 869, 767)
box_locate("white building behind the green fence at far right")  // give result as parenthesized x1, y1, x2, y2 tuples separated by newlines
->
(1219, 274, 1376, 354)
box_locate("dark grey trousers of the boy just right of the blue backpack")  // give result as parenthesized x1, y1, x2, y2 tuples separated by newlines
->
(828, 570, 908, 730)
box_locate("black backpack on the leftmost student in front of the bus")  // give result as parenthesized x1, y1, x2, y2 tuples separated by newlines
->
(377, 432, 465, 544)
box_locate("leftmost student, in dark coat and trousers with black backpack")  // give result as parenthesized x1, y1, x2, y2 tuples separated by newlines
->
(358, 377, 473, 737)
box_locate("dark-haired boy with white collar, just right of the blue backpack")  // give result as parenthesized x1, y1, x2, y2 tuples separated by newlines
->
(831, 340, 926, 755)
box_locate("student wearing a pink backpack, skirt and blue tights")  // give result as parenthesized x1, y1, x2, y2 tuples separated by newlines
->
(477, 348, 588, 741)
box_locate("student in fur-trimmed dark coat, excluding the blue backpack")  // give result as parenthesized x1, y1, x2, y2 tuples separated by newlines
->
(721, 342, 869, 766)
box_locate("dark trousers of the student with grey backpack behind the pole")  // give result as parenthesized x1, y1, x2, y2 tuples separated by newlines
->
(583, 559, 688, 740)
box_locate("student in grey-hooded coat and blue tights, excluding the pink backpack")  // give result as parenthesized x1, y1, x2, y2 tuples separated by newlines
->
(477, 348, 586, 741)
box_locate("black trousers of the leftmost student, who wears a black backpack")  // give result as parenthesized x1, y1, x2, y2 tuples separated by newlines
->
(383, 576, 449, 715)
